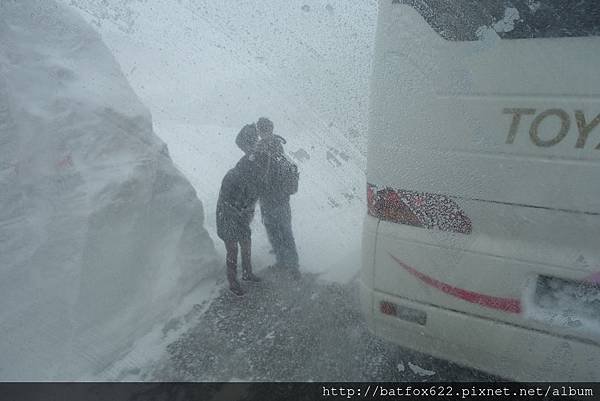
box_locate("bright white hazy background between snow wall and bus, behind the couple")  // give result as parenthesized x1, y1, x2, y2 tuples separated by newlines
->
(63, 0, 366, 281)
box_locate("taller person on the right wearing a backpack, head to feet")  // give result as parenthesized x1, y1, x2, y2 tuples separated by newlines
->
(255, 117, 300, 277)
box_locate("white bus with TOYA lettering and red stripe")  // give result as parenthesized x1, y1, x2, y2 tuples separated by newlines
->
(361, 0, 600, 381)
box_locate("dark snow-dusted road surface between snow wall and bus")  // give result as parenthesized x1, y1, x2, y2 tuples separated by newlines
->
(152, 269, 493, 381)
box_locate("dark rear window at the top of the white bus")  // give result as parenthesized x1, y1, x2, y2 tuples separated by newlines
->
(392, 0, 600, 41)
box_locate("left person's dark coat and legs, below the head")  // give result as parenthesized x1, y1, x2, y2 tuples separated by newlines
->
(217, 150, 267, 296)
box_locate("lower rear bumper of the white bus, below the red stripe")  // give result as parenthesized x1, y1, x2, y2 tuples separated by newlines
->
(360, 283, 600, 381)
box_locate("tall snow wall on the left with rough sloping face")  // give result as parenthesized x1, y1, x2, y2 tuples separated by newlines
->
(0, 0, 217, 380)
